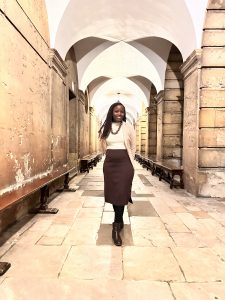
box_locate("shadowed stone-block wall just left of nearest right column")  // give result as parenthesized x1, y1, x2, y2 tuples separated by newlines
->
(162, 46, 183, 161)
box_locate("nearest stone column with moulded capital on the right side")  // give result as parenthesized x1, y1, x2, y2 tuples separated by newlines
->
(181, 50, 201, 195)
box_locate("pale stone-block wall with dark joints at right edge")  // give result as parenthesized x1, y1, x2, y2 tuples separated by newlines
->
(198, 0, 225, 197)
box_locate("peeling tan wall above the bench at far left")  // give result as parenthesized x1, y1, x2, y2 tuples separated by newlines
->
(0, 1, 51, 194)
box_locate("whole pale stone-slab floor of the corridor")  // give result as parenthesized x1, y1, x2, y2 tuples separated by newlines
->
(0, 163, 225, 300)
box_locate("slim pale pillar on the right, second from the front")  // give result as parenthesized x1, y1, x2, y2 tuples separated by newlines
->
(155, 91, 164, 160)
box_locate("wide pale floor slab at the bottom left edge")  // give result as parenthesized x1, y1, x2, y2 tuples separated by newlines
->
(0, 278, 174, 300)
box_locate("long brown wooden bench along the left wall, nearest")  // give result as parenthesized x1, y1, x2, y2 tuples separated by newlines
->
(0, 166, 76, 276)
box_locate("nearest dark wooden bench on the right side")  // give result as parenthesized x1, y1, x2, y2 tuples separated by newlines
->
(152, 160, 184, 189)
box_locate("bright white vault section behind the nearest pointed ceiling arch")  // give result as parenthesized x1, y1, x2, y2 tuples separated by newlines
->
(78, 42, 165, 91)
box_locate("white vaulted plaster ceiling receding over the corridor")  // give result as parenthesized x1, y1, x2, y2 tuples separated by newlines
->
(46, 0, 208, 119)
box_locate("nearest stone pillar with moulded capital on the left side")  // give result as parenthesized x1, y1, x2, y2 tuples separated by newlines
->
(49, 49, 69, 169)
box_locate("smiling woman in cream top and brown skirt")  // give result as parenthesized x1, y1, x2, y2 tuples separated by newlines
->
(99, 102, 136, 246)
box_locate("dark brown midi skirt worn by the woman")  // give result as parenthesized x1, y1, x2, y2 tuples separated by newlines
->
(103, 149, 134, 206)
